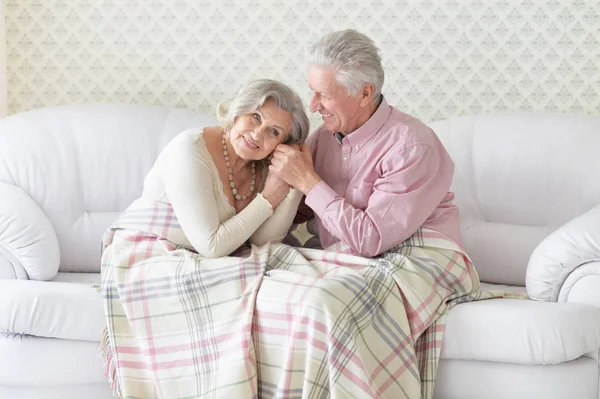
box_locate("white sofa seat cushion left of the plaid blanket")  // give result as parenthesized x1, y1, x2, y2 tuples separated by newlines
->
(0, 273, 105, 341)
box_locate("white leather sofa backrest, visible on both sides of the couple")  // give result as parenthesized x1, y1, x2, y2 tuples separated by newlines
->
(0, 104, 600, 285)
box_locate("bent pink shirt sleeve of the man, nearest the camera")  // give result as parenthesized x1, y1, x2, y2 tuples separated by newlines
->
(306, 144, 454, 257)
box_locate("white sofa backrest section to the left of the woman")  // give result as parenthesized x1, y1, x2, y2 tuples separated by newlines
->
(0, 104, 218, 272)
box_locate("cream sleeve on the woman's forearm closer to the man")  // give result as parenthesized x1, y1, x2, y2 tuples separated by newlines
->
(250, 189, 303, 245)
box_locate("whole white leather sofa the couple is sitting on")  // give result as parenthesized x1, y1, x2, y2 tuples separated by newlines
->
(0, 104, 600, 399)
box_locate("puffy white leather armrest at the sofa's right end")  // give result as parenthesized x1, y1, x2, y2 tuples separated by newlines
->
(526, 205, 600, 302)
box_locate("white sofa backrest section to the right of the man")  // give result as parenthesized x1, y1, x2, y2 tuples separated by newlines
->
(430, 114, 600, 286)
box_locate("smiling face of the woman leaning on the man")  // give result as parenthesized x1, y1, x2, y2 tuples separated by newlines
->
(229, 99, 292, 161)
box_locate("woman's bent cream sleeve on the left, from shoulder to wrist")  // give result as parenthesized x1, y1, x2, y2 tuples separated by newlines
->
(157, 138, 273, 258)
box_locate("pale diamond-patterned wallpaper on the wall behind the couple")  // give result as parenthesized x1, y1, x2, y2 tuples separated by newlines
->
(5, 0, 600, 121)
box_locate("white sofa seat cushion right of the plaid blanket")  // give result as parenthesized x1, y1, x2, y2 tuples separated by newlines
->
(441, 299, 600, 365)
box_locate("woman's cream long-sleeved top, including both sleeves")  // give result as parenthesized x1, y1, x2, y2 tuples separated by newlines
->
(142, 129, 302, 258)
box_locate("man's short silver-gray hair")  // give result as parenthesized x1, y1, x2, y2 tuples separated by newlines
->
(307, 29, 385, 102)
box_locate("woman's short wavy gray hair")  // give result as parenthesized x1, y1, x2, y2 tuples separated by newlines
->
(217, 79, 310, 144)
